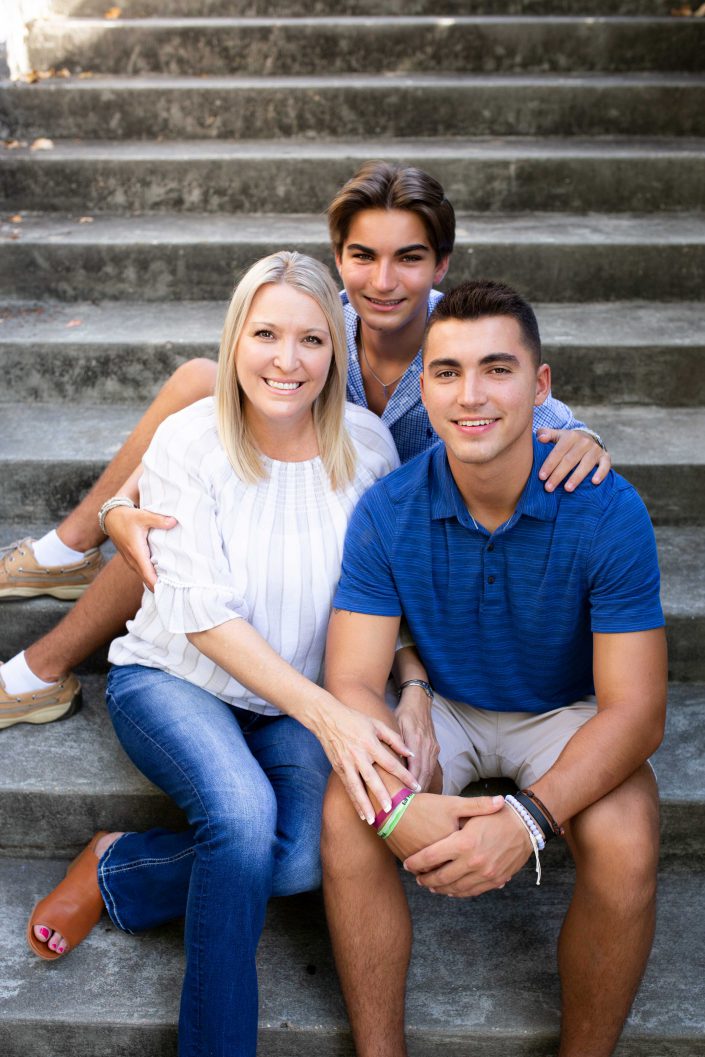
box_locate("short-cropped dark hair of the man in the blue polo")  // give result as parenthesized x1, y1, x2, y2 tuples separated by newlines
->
(424, 279, 541, 367)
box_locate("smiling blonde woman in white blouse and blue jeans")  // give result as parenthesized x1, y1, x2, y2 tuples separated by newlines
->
(29, 253, 418, 1057)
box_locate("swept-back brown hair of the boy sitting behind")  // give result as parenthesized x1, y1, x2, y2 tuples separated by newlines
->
(327, 162, 456, 261)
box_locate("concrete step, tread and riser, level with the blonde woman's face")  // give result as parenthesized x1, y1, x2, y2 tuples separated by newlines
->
(0, 301, 705, 407)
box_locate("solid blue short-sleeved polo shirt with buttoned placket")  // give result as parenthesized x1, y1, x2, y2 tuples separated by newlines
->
(334, 439, 664, 712)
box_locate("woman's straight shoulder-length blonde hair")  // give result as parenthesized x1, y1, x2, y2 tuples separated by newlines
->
(216, 249, 355, 489)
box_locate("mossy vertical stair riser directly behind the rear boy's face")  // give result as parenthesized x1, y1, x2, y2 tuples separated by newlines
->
(0, 239, 705, 302)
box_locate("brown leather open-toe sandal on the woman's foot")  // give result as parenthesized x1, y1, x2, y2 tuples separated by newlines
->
(26, 830, 108, 962)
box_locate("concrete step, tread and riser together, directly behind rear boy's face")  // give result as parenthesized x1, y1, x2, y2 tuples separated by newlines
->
(0, 210, 705, 302)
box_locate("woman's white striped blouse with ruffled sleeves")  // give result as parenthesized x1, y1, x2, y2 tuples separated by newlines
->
(109, 397, 398, 715)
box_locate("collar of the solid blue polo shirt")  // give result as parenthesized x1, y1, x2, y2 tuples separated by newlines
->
(428, 437, 558, 526)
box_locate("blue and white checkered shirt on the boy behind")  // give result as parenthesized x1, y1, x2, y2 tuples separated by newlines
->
(340, 290, 585, 463)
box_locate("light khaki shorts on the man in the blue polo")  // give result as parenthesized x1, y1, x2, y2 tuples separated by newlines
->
(432, 694, 597, 795)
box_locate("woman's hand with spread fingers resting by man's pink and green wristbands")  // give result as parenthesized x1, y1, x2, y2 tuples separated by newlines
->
(312, 702, 420, 824)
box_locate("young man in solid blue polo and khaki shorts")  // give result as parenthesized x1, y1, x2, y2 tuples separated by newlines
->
(322, 282, 667, 1057)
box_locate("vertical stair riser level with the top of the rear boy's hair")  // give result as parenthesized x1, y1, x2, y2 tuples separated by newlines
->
(0, 150, 705, 214)
